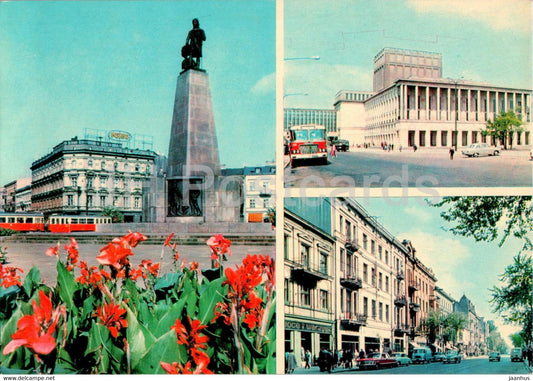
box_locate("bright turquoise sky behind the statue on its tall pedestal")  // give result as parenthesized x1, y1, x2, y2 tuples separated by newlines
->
(0, 0, 276, 185)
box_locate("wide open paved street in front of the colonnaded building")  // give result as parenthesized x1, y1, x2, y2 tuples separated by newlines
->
(285, 148, 532, 188)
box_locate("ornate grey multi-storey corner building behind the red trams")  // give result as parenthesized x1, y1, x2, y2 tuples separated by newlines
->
(31, 138, 156, 222)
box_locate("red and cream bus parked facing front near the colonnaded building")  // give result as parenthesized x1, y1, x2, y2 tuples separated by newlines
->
(289, 124, 328, 167)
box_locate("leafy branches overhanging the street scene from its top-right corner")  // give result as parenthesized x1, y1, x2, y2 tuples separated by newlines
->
(429, 196, 533, 250)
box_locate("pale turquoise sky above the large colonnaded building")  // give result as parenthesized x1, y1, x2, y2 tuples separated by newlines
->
(284, 0, 532, 108)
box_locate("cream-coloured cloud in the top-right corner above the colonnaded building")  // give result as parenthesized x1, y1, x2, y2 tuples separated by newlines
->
(407, 0, 531, 34)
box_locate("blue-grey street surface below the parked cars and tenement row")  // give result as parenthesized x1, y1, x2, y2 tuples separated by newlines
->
(294, 356, 530, 376)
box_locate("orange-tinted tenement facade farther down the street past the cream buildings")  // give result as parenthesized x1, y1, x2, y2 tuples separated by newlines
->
(402, 240, 437, 346)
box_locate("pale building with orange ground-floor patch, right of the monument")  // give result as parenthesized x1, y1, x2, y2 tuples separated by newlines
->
(244, 164, 276, 222)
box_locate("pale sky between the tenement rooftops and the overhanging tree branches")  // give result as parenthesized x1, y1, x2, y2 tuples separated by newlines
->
(356, 197, 522, 342)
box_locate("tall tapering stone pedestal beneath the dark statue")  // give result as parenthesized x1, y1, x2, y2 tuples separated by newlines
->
(166, 70, 240, 222)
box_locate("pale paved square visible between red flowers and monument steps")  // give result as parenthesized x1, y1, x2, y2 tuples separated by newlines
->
(1, 242, 275, 285)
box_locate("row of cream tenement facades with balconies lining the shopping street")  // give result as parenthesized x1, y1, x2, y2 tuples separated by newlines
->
(284, 197, 476, 364)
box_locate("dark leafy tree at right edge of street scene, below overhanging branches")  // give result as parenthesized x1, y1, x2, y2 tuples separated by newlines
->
(490, 254, 533, 345)
